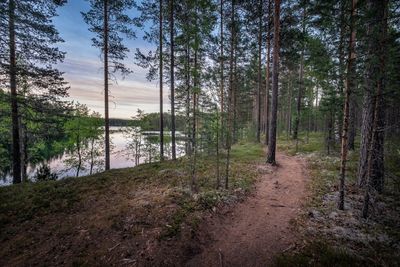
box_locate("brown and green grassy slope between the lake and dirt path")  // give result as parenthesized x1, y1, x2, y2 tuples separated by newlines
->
(0, 144, 263, 266)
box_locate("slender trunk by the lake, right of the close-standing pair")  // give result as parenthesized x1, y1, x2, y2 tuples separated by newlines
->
(169, 0, 176, 160)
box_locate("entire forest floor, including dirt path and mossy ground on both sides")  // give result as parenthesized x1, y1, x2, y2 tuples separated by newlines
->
(0, 134, 400, 267)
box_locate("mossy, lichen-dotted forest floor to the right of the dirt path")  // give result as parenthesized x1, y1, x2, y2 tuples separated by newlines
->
(275, 133, 400, 266)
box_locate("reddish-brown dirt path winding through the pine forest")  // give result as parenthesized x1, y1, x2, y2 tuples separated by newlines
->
(187, 154, 307, 266)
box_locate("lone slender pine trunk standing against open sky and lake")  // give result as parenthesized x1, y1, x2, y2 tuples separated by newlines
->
(103, 0, 110, 170)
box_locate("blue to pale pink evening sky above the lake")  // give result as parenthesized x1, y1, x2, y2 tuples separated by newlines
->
(54, 0, 165, 118)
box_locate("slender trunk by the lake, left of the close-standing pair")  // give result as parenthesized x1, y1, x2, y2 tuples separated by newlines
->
(159, 0, 164, 160)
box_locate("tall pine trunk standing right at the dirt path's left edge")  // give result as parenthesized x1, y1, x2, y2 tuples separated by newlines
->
(267, 0, 281, 165)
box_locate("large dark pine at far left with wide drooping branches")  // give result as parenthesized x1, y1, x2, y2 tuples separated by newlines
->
(0, 0, 68, 183)
